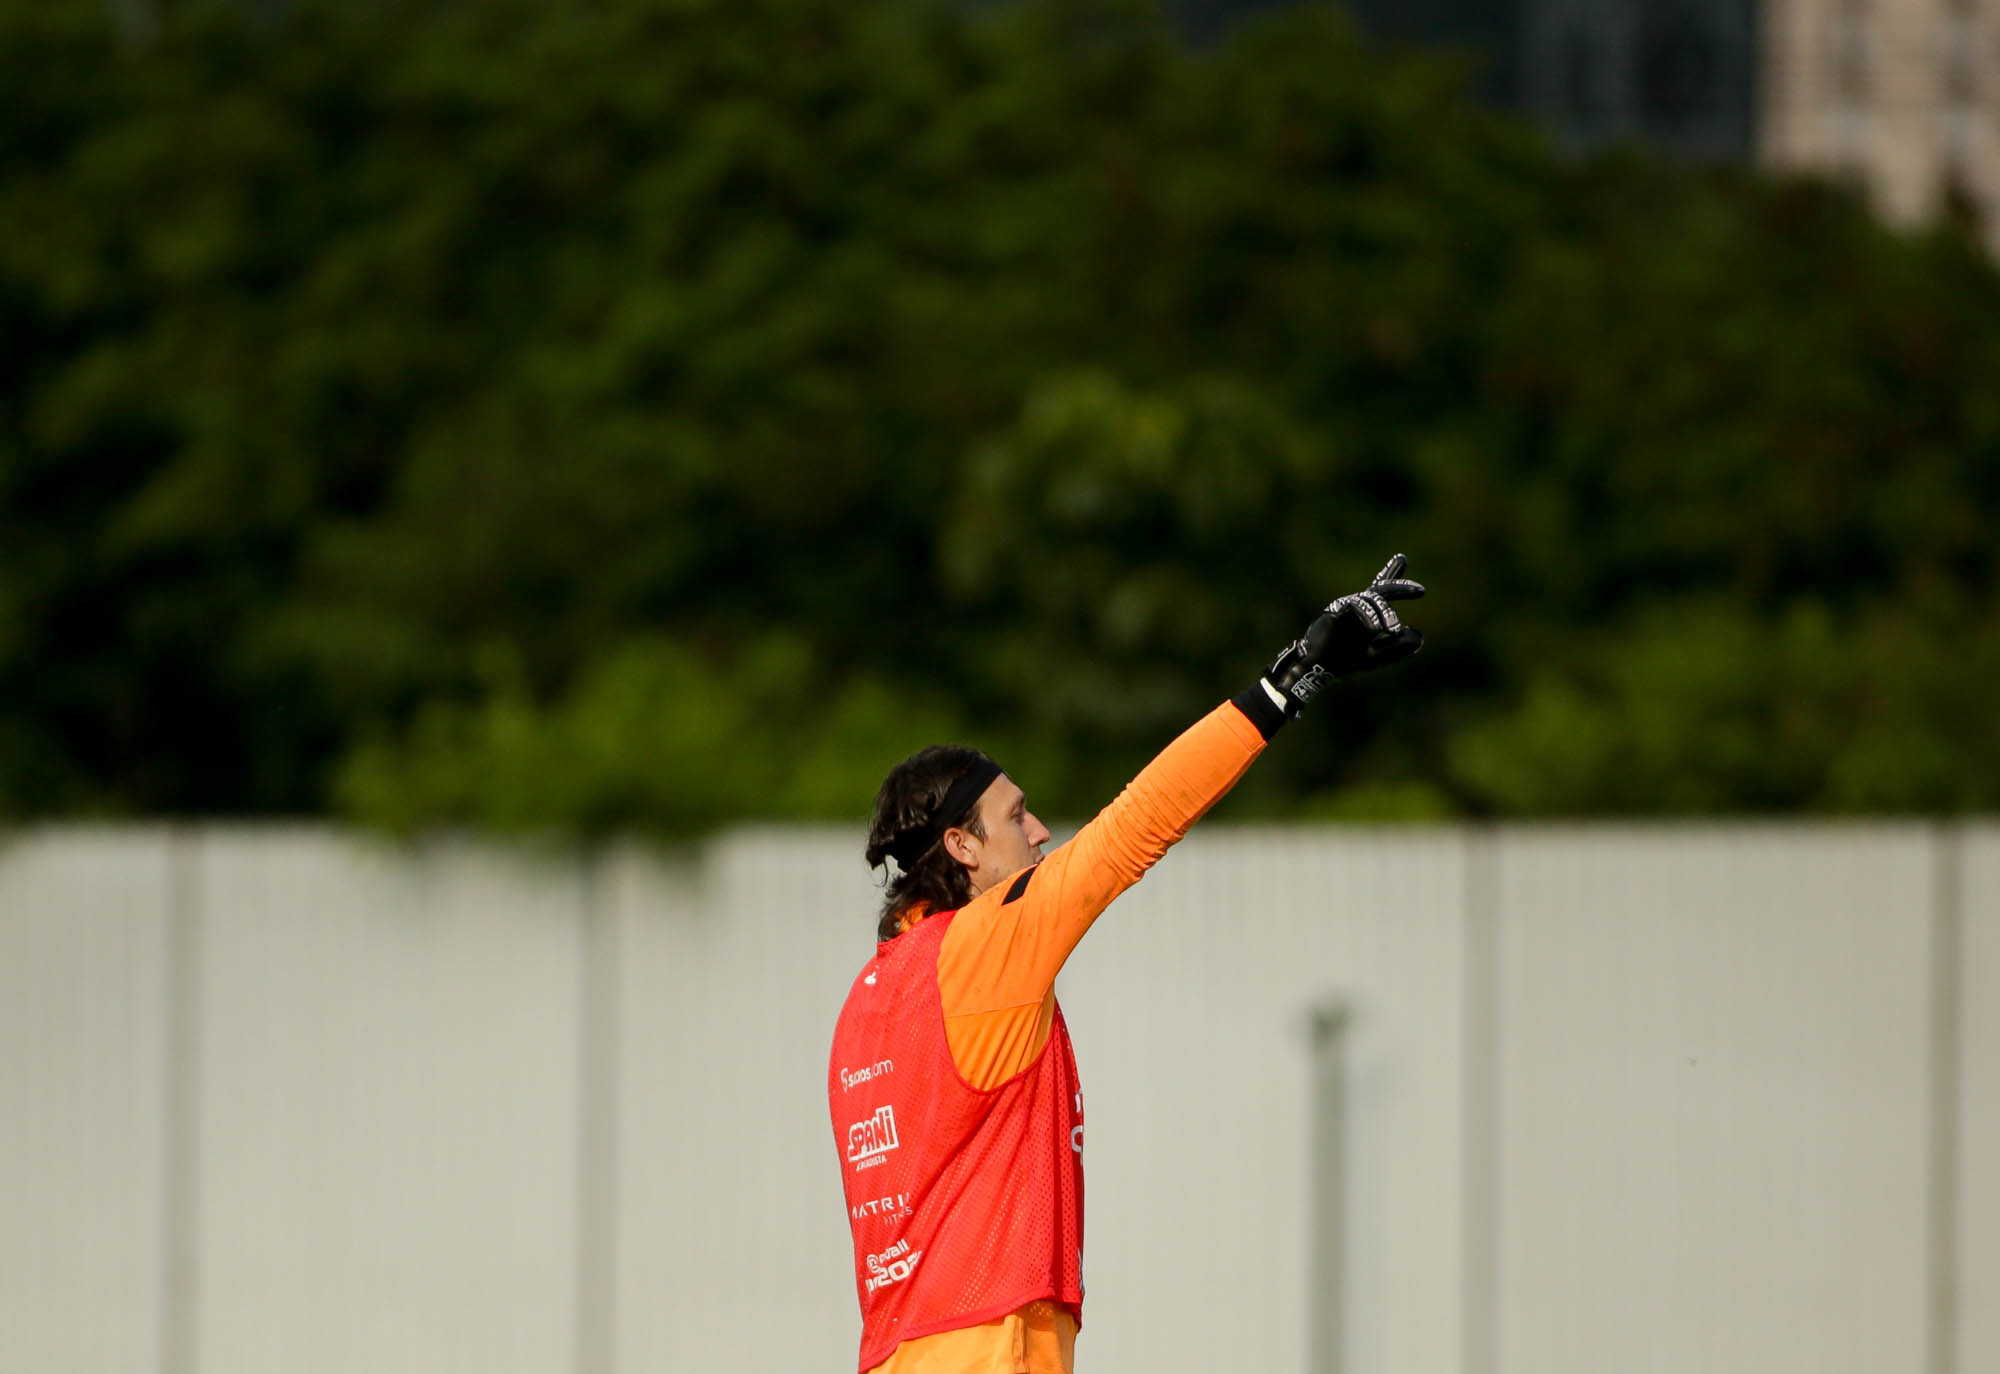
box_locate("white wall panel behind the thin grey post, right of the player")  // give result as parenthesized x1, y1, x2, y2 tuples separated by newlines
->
(1058, 830, 1466, 1370)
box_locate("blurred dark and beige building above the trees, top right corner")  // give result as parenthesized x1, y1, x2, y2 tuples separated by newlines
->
(1348, 0, 2000, 252)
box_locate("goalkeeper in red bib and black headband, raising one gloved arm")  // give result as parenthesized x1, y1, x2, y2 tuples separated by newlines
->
(826, 554, 1424, 1374)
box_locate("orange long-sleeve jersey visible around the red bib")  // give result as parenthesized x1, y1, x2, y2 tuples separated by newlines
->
(870, 704, 1264, 1374)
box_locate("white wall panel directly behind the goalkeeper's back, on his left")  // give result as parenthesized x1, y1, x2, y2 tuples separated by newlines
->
(592, 832, 876, 1374)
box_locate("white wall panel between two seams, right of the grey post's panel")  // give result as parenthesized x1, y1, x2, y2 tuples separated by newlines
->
(1498, 828, 1932, 1374)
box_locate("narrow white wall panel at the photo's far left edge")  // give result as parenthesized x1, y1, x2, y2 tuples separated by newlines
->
(0, 830, 170, 1374)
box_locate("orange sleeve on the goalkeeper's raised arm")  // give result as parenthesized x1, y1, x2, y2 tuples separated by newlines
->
(938, 702, 1264, 1082)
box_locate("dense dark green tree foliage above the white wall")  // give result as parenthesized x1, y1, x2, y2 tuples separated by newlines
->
(0, 0, 2000, 832)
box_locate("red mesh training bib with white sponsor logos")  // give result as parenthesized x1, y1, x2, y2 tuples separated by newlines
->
(826, 914, 1084, 1370)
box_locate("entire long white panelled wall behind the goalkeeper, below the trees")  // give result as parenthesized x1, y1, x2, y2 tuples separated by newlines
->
(0, 826, 2000, 1374)
